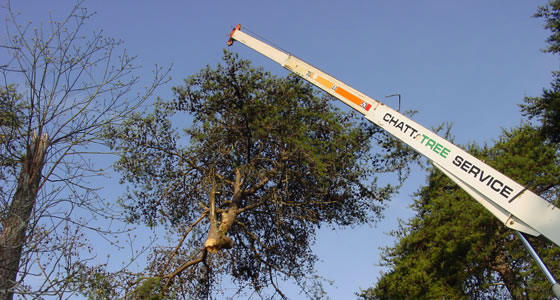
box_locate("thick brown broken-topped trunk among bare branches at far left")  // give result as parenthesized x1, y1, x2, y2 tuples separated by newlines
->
(0, 134, 48, 299)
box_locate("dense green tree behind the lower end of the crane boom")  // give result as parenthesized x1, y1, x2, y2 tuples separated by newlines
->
(361, 125, 560, 299)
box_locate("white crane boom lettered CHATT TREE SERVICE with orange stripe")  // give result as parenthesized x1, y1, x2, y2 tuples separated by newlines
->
(228, 25, 560, 298)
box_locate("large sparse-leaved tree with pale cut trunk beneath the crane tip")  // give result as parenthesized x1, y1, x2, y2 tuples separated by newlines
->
(108, 52, 415, 299)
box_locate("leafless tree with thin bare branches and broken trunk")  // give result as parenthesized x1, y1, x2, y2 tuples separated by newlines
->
(0, 1, 165, 299)
